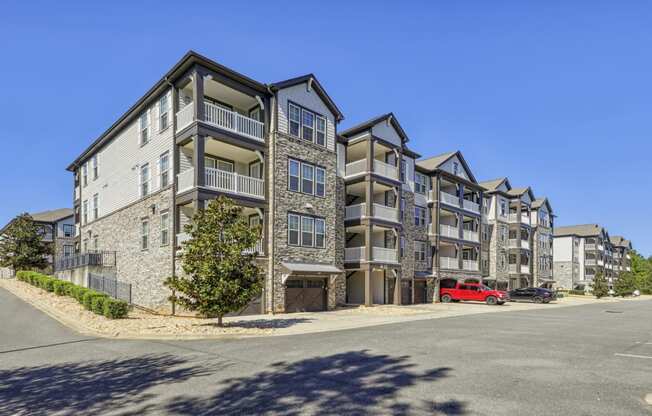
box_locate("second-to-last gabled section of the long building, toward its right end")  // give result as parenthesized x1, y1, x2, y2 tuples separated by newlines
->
(480, 178, 535, 290)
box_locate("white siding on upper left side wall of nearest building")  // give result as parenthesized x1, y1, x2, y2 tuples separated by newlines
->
(81, 91, 173, 219)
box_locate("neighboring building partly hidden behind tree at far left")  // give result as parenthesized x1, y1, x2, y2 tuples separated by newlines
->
(0, 208, 75, 277)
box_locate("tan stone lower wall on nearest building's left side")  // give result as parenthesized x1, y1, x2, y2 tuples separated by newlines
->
(81, 187, 174, 311)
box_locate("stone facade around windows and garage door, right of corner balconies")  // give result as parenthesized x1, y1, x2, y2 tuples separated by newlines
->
(267, 133, 346, 312)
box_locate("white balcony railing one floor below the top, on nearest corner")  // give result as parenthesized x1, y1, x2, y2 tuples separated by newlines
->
(177, 168, 265, 199)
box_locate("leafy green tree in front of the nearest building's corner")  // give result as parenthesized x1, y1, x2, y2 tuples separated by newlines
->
(166, 196, 262, 326)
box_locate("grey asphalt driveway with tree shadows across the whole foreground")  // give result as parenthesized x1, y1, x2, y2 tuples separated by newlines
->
(0, 289, 652, 415)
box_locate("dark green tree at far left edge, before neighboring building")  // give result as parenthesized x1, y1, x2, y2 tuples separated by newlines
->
(0, 213, 52, 271)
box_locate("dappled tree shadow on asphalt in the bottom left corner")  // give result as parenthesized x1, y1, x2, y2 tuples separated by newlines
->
(0, 355, 215, 415)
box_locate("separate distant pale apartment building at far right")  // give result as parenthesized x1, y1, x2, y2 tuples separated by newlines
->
(554, 224, 631, 289)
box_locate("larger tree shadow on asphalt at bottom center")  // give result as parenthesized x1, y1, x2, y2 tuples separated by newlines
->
(153, 350, 466, 416)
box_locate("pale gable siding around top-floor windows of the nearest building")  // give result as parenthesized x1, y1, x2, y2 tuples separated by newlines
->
(278, 82, 335, 152)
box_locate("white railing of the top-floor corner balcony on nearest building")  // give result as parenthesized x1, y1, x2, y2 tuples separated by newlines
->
(176, 101, 265, 142)
